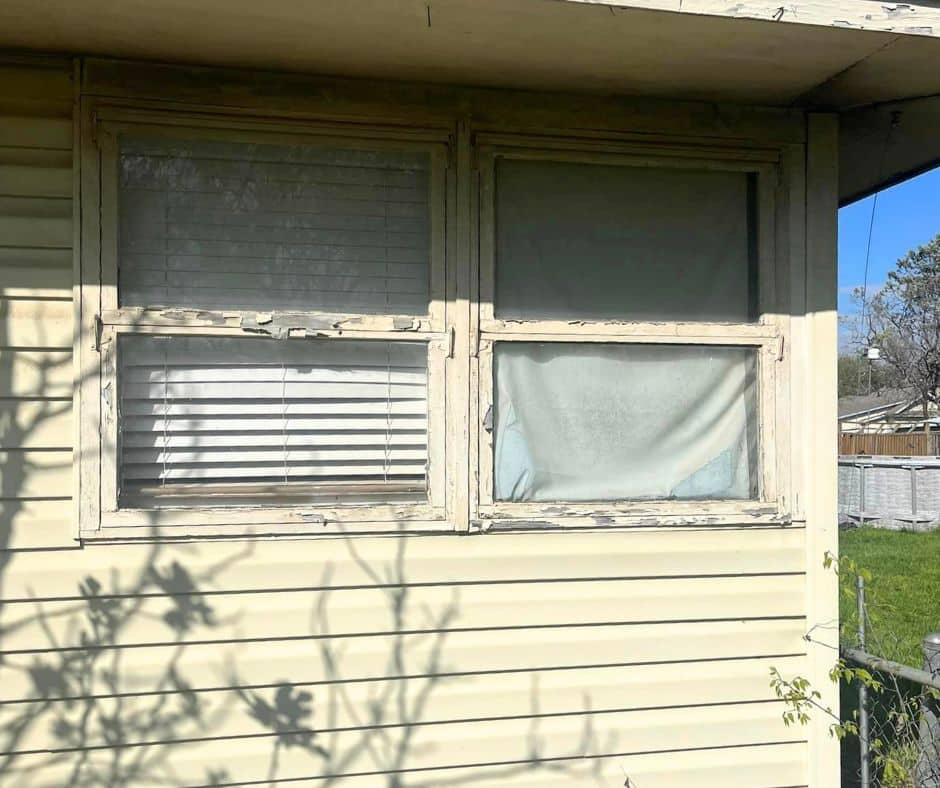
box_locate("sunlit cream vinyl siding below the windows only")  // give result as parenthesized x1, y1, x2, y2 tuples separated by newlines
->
(0, 528, 805, 785)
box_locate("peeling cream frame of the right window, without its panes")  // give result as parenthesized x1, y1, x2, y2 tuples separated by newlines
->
(473, 134, 790, 530)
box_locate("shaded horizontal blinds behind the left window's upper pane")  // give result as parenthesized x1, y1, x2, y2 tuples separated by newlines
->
(118, 137, 431, 315)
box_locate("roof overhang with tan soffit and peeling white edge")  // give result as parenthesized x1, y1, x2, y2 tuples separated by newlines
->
(0, 0, 940, 200)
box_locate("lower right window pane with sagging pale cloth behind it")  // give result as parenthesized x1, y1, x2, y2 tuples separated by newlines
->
(494, 342, 758, 501)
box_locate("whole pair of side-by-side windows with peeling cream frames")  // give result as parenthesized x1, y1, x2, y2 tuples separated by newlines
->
(80, 104, 788, 538)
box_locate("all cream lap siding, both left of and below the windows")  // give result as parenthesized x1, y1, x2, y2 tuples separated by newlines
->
(0, 63, 807, 788)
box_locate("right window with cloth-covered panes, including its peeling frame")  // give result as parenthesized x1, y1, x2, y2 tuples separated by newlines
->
(478, 140, 784, 522)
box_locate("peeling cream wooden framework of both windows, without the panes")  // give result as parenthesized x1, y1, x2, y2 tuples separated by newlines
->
(76, 101, 802, 541)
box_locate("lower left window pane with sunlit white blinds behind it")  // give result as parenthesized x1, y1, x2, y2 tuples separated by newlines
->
(118, 335, 428, 505)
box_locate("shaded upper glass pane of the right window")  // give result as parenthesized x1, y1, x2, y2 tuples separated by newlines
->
(495, 159, 756, 322)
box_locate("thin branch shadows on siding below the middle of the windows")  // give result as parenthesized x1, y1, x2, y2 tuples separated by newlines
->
(228, 536, 609, 788)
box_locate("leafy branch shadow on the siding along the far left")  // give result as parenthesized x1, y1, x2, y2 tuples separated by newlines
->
(0, 310, 258, 786)
